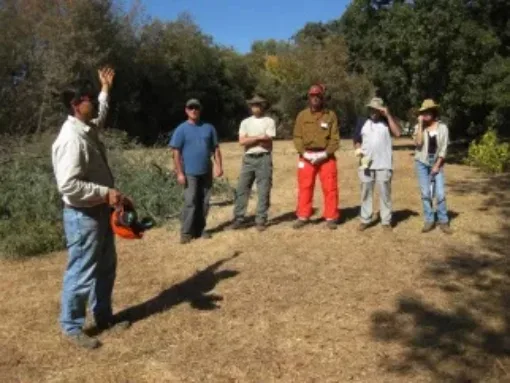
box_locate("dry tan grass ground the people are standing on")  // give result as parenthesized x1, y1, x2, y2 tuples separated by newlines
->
(0, 139, 510, 382)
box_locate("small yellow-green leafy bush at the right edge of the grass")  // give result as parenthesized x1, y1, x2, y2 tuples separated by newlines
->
(467, 129, 510, 173)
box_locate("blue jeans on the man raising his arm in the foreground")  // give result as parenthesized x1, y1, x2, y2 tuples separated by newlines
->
(60, 205, 117, 335)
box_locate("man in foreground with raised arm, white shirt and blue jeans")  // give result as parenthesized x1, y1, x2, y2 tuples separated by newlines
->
(52, 68, 132, 349)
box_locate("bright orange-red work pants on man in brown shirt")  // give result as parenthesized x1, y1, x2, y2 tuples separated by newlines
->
(296, 158, 339, 220)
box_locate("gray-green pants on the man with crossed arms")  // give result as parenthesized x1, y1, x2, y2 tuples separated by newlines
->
(234, 154, 273, 224)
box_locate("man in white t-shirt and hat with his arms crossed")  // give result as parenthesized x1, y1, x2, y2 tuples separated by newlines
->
(232, 96, 276, 231)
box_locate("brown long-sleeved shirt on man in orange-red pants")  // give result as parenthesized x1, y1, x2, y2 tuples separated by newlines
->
(294, 108, 340, 155)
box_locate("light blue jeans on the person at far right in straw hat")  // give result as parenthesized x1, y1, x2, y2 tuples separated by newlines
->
(415, 156, 448, 224)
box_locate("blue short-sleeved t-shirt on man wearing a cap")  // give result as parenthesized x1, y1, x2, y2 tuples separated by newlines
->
(170, 121, 218, 176)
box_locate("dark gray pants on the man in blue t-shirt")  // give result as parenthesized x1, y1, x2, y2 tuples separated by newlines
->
(181, 173, 212, 237)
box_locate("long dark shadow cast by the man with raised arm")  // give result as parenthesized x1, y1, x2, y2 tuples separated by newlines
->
(101, 252, 241, 332)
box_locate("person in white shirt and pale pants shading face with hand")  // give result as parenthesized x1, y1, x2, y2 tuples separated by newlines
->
(354, 97, 401, 231)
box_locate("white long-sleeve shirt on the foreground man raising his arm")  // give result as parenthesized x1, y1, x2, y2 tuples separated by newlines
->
(52, 92, 114, 207)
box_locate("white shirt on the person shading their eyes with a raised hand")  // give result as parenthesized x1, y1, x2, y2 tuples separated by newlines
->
(360, 119, 393, 170)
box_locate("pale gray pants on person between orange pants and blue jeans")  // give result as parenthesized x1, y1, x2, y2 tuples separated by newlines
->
(358, 169, 393, 225)
